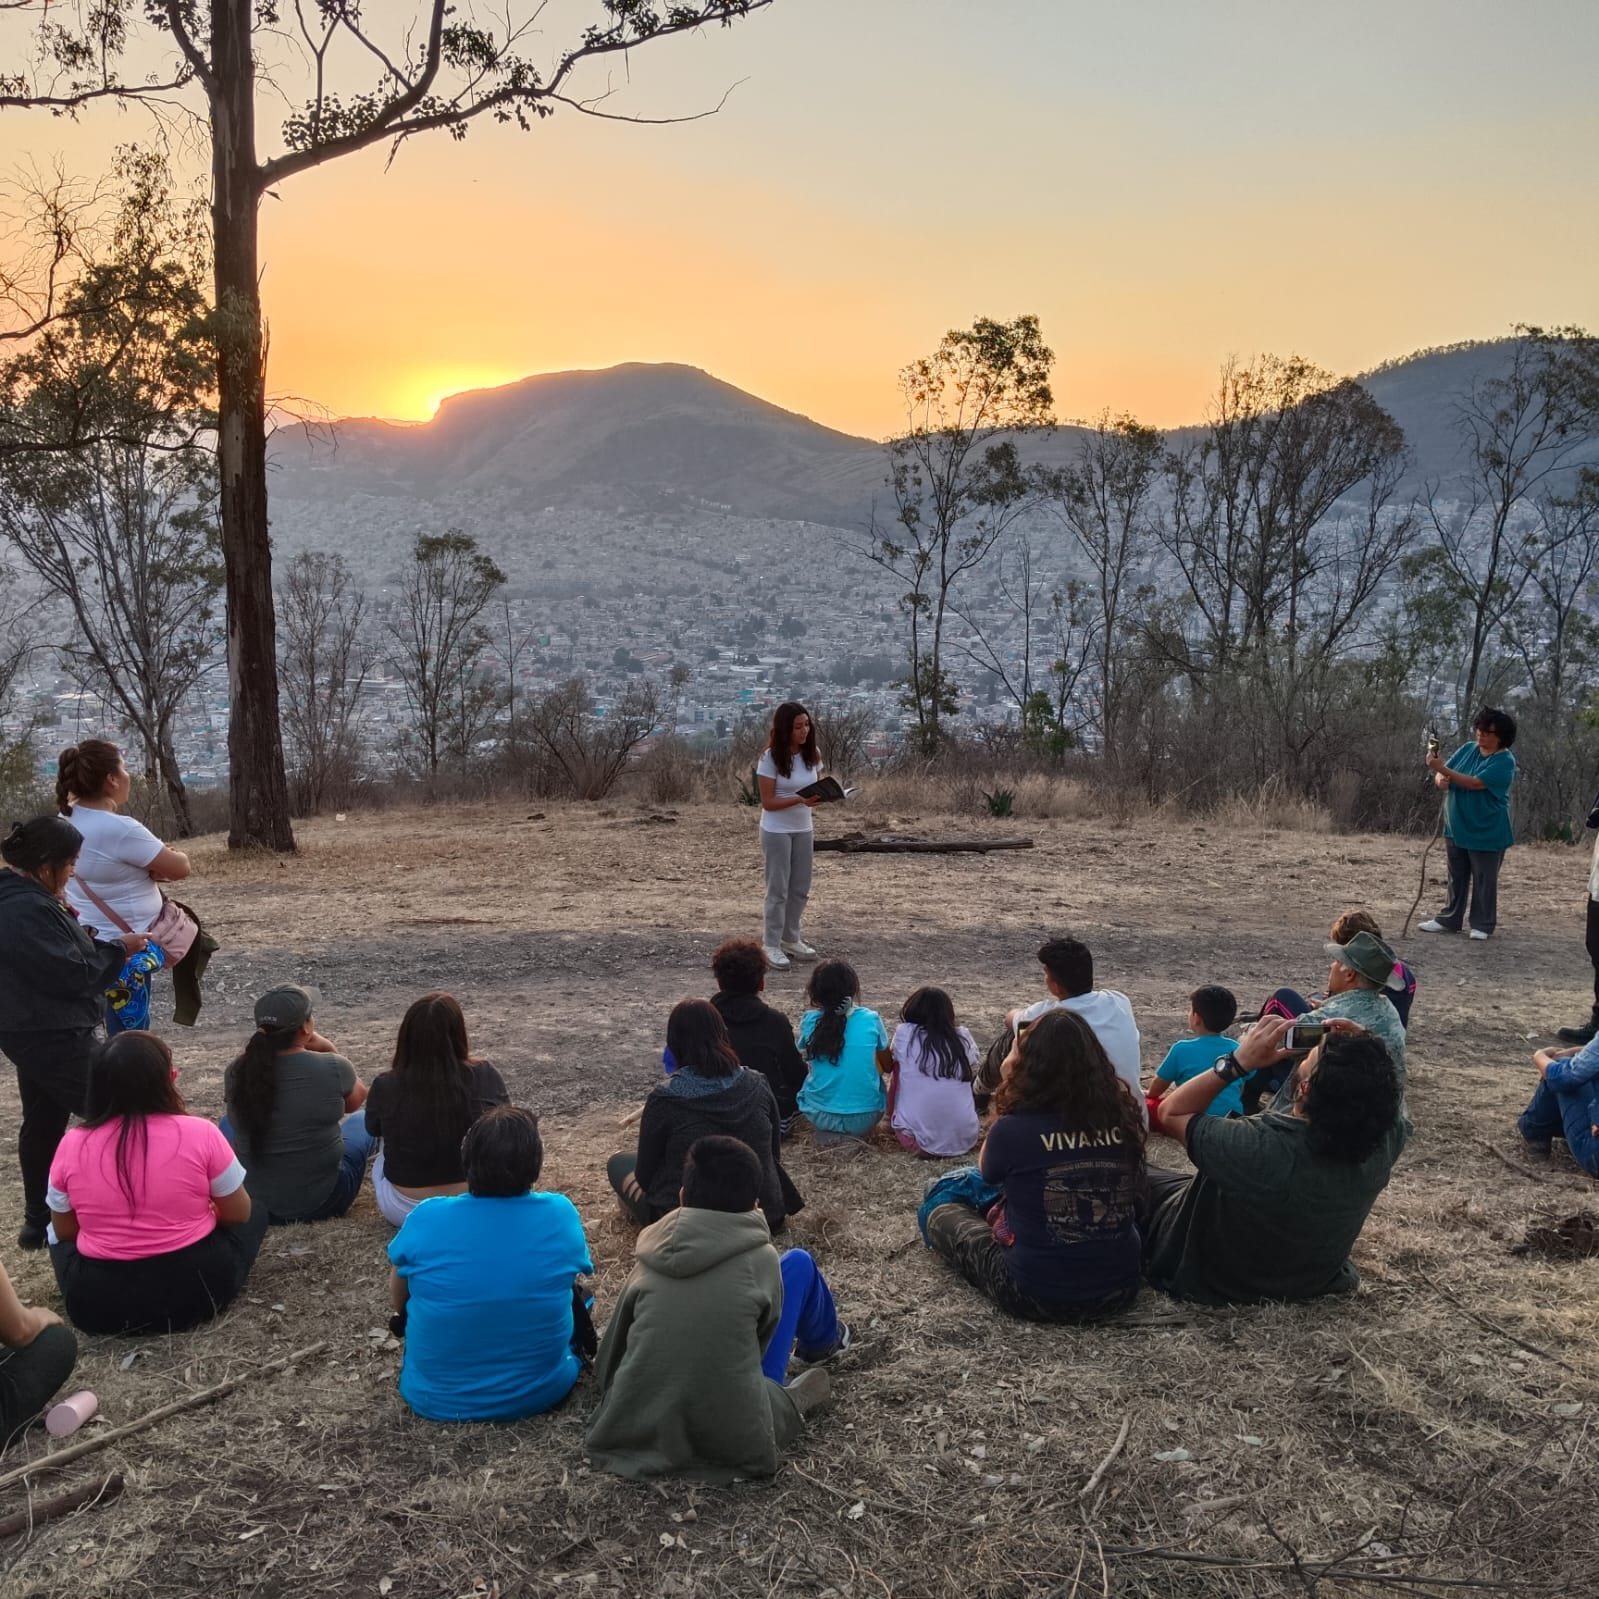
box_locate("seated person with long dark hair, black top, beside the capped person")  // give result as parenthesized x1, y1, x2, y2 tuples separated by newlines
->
(366, 993, 510, 1226)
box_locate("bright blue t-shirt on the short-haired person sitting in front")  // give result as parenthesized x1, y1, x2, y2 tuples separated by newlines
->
(389, 1193, 593, 1422)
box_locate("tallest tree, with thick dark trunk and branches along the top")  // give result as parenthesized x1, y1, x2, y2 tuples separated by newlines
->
(0, 0, 771, 849)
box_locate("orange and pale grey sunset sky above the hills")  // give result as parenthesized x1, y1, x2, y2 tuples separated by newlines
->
(0, 0, 1599, 437)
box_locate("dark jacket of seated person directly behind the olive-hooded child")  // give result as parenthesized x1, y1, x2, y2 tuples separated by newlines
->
(633, 1070, 804, 1233)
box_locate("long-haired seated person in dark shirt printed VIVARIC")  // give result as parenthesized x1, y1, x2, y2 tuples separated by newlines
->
(923, 1011, 1146, 1321)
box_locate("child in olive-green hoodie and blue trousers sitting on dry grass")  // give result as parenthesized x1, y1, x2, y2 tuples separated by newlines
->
(585, 1135, 849, 1482)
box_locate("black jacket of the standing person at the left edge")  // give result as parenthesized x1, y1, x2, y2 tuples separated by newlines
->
(0, 868, 128, 1033)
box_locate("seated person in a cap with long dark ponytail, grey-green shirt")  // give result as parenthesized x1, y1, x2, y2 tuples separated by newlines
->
(222, 983, 376, 1226)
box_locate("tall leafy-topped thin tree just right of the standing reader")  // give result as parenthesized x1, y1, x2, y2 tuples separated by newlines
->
(865, 317, 1055, 755)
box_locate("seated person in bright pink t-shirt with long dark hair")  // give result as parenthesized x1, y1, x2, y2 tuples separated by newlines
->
(45, 1033, 267, 1332)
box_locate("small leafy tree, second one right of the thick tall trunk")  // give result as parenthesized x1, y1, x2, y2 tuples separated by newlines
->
(389, 529, 505, 777)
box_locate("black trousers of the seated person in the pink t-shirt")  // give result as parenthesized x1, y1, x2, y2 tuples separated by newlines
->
(50, 1204, 267, 1332)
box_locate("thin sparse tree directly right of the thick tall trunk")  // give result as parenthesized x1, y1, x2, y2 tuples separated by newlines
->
(278, 550, 373, 815)
